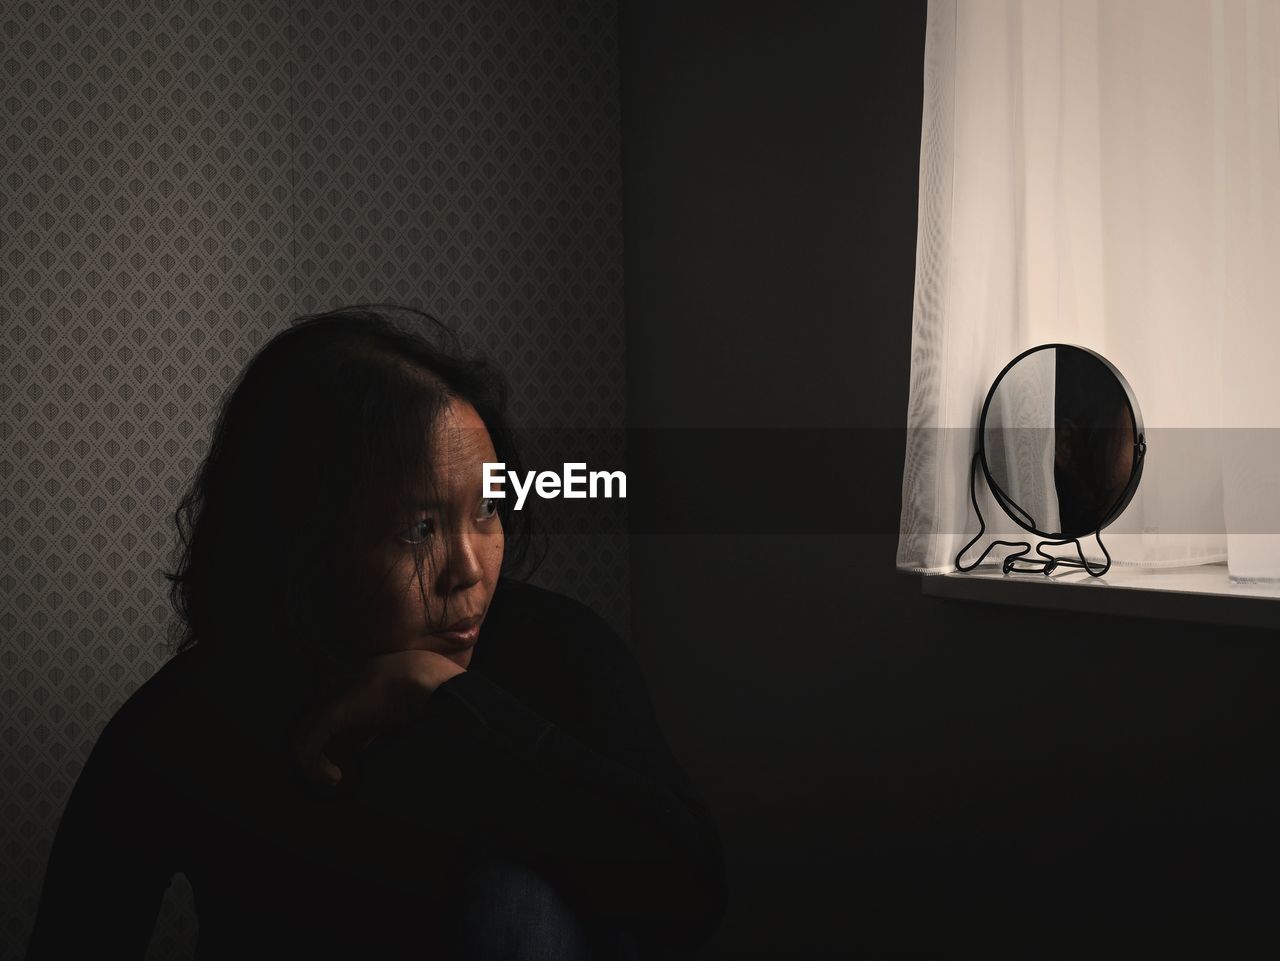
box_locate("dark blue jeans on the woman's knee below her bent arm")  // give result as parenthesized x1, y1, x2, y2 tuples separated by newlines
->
(451, 848, 640, 961)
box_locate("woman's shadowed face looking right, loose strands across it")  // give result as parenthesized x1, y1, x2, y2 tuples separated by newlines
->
(360, 401, 506, 668)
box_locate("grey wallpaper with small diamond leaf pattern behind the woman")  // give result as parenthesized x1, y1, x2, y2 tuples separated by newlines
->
(0, 0, 627, 957)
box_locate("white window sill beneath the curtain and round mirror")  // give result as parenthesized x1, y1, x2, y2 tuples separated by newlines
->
(920, 563, 1280, 630)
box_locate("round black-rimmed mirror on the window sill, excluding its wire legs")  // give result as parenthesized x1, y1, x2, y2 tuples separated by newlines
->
(978, 344, 1146, 540)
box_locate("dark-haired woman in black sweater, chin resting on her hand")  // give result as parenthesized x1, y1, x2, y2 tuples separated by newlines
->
(28, 308, 724, 958)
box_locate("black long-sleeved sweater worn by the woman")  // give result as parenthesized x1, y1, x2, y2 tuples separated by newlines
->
(28, 578, 726, 961)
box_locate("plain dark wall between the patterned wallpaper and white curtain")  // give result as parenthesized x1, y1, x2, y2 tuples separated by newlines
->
(620, 0, 1280, 958)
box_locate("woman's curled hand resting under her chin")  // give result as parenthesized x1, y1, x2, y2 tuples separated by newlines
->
(293, 650, 463, 784)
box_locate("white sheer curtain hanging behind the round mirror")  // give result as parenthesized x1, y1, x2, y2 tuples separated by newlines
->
(897, 0, 1280, 578)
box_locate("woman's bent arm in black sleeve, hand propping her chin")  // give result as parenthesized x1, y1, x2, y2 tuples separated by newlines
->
(358, 604, 726, 942)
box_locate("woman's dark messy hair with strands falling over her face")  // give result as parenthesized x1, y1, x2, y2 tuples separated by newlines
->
(165, 305, 536, 671)
